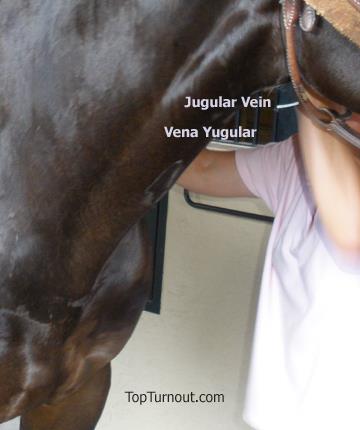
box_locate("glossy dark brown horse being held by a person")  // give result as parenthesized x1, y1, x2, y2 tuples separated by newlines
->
(0, 0, 360, 430)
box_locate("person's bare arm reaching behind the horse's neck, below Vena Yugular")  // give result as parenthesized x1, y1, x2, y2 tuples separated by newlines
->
(177, 149, 252, 197)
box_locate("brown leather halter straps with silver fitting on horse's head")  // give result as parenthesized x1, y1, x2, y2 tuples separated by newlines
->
(280, 0, 360, 148)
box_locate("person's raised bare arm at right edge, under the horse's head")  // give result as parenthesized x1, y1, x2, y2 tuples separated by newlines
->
(298, 112, 360, 256)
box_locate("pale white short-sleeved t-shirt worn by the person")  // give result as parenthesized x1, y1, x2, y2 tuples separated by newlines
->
(236, 138, 360, 430)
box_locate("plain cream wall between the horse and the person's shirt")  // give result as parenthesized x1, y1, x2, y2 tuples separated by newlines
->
(0, 187, 269, 430)
